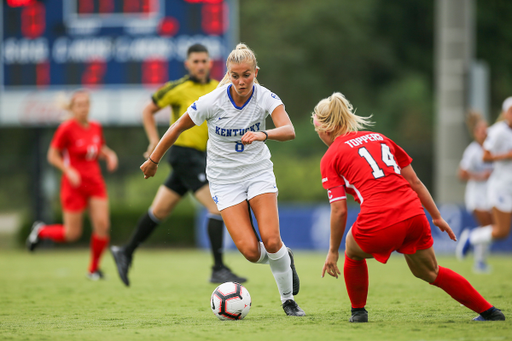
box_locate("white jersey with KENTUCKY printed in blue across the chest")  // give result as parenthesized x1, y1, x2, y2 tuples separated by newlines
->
(187, 84, 283, 184)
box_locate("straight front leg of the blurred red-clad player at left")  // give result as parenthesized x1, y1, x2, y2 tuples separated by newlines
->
(87, 197, 110, 280)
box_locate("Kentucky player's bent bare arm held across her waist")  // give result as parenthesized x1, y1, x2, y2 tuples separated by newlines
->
(242, 105, 295, 144)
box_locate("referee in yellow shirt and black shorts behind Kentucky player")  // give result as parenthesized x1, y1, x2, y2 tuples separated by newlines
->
(110, 44, 247, 286)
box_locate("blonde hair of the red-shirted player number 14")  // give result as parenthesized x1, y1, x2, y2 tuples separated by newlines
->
(312, 92, 373, 138)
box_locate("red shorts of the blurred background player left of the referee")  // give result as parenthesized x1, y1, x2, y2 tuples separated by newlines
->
(60, 176, 107, 212)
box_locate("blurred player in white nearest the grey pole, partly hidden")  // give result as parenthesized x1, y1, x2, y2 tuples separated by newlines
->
(459, 111, 492, 273)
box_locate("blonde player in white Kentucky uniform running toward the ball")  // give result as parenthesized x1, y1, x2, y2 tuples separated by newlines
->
(141, 44, 305, 316)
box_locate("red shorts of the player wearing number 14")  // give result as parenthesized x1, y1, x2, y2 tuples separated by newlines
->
(352, 214, 434, 264)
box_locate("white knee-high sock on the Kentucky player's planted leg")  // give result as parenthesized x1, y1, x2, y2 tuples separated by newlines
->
(268, 244, 293, 303)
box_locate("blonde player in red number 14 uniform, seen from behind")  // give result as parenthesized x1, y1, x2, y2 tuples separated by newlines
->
(313, 93, 505, 322)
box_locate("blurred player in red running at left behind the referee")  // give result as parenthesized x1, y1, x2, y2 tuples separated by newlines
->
(27, 90, 118, 280)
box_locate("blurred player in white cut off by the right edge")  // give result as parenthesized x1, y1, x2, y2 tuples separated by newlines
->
(456, 97, 512, 258)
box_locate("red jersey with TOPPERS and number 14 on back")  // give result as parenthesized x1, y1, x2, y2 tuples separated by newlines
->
(320, 131, 424, 232)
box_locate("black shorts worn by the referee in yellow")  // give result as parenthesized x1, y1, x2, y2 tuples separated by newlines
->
(164, 146, 208, 196)
